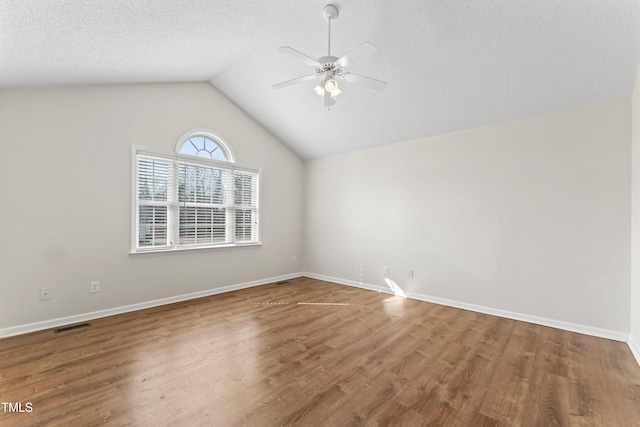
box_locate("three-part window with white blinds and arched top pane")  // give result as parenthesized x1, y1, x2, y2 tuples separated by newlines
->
(132, 134, 260, 252)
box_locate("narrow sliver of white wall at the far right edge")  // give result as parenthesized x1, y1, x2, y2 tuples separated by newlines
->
(629, 73, 640, 364)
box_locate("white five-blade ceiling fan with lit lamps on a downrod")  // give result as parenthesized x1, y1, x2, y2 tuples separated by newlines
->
(272, 4, 387, 107)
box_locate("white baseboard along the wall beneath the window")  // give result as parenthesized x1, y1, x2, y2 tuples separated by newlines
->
(0, 273, 304, 338)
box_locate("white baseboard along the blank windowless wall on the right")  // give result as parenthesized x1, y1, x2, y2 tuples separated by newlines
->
(304, 273, 640, 344)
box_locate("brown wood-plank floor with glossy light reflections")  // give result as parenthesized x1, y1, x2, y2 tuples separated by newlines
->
(0, 278, 640, 427)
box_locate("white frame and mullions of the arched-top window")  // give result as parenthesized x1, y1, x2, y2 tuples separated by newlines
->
(130, 147, 262, 254)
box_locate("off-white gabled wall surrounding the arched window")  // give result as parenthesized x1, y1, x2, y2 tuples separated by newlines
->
(0, 83, 303, 332)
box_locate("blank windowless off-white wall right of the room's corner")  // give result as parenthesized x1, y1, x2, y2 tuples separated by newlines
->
(305, 99, 631, 336)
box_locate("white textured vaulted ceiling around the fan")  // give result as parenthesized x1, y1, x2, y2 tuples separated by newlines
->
(0, 0, 640, 158)
